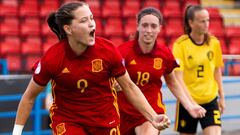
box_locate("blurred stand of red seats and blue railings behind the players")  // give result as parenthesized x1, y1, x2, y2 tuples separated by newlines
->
(0, 0, 240, 135)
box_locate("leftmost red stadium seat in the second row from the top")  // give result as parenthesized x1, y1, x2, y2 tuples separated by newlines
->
(0, 17, 19, 36)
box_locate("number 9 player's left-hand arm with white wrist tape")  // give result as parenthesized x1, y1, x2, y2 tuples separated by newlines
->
(13, 79, 44, 135)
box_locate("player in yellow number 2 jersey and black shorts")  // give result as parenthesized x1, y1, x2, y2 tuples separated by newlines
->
(173, 5, 225, 135)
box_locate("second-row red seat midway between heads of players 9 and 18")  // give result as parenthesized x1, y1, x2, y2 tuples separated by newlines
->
(104, 18, 123, 36)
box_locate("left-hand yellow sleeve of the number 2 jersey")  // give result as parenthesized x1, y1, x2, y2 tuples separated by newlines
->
(173, 42, 184, 71)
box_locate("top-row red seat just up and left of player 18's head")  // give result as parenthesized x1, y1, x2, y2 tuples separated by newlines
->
(122, 0, 140, 18)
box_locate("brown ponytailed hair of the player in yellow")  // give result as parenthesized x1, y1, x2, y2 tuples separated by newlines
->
(184, 5, 210, 44)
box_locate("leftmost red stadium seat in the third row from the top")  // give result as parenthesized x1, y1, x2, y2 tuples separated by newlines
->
(1, 36, 21, 55)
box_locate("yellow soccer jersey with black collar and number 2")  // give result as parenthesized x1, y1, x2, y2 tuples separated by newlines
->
(173, 35, 223, 104)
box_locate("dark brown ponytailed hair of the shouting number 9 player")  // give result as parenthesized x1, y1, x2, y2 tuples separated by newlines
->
(47, 1, 88, 40)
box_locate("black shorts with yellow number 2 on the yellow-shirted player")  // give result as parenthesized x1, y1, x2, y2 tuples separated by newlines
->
(175, 97, 221, 134)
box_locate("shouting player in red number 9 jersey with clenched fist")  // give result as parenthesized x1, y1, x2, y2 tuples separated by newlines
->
(13, 2, 170, 135)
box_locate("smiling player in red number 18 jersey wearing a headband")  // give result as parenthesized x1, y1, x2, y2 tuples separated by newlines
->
(116, 8, 205, 135)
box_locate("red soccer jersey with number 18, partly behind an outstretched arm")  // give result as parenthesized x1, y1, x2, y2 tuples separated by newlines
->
(118, 40, 178, 116)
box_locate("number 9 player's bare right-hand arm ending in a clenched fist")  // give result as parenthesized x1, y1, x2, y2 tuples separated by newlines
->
(116, 72, 170, 130)
